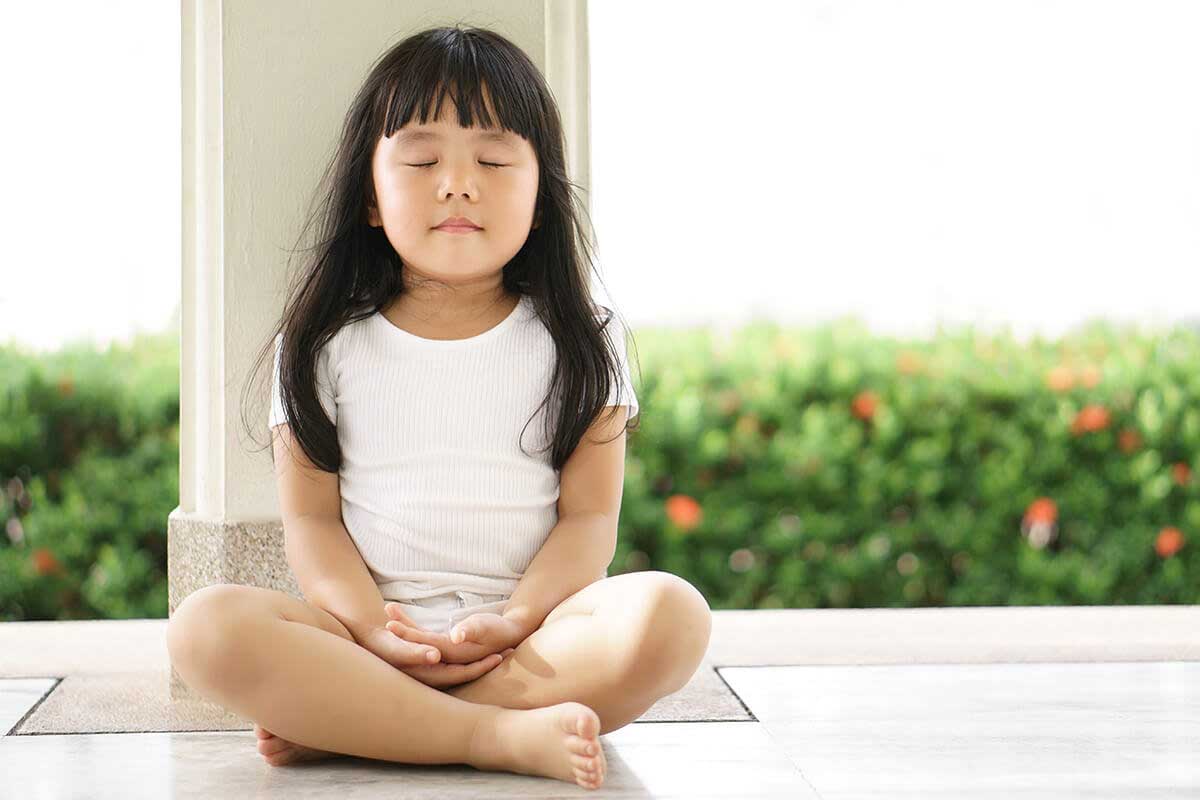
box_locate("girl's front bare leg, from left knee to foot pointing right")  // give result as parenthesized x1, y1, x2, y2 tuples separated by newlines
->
(167, 584, 609, 788)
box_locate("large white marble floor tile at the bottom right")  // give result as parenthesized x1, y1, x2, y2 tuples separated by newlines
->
(720, 662, 1200, 800)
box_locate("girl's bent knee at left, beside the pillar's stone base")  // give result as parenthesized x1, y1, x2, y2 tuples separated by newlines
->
(167, 583, 256, 680)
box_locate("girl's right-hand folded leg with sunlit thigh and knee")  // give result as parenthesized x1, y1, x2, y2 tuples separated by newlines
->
(445, 571, 712, 734)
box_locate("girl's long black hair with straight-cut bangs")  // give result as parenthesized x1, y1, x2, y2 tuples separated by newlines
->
(242, 26, 641, 473)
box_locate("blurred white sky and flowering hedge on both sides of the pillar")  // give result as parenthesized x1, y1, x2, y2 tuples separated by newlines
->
(0, 0, 1200, 619)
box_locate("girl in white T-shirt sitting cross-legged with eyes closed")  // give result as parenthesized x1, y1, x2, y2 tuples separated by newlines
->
(167, 28, 712, 788)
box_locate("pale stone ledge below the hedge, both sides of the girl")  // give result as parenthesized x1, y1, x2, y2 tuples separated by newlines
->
(0, 606, 1200, 678)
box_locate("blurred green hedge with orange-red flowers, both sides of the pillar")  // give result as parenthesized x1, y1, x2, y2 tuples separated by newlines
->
(0, 320, 1200, 619)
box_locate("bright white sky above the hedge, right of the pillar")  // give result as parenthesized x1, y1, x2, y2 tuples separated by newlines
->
(589, 0, 1200, 338)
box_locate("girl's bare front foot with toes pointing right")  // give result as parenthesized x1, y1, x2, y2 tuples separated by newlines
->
(468, 702, 608, 789)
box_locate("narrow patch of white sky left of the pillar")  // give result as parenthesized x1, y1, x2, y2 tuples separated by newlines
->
(0, 0, 181, 350)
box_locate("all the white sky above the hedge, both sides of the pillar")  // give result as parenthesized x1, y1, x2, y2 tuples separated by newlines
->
(0, 0, 1200, 349)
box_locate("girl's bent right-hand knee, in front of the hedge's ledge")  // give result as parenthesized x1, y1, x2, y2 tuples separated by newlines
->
(640, 572, 713, 692)
